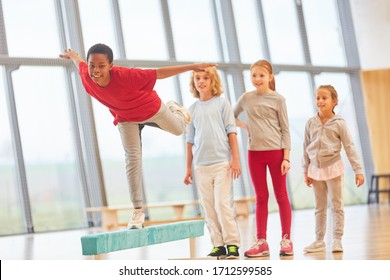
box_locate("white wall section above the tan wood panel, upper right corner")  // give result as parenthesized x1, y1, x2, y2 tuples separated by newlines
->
(350, 0, 390, 70)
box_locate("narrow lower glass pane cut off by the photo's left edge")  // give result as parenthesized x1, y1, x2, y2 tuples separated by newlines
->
(0, 67, 26, 235)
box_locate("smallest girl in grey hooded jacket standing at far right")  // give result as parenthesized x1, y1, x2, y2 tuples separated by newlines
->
(303, 85, 364, 253)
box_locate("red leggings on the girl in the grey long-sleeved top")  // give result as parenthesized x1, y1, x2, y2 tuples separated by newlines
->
(248, 150, 291, 239)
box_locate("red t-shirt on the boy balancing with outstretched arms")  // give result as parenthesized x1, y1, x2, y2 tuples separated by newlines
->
(79, 62, 161, 125)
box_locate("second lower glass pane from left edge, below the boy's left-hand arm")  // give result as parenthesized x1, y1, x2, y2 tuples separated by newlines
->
(12, 66, 85, 232)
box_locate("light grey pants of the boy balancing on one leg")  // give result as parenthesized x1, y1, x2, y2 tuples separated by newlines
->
(118, 103, 185, 208)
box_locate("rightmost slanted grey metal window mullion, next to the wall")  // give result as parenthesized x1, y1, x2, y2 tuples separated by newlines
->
(337, 0, 374, 186)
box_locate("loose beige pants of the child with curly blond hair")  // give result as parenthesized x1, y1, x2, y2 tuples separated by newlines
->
(194, 162, 240, 247)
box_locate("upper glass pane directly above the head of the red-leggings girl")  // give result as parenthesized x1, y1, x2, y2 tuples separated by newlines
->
(232, 0, 264, 63)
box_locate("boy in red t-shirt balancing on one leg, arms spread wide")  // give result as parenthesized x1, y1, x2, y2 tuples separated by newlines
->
(59, 44, 217, 229)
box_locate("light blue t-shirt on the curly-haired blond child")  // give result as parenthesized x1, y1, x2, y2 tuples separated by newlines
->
(186, 96, 237, 166)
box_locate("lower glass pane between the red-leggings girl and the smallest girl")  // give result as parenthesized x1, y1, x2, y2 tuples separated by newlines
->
(275, 72, 315, 209)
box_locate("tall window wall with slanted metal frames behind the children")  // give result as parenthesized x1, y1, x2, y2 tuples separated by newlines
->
(0, 0, 372, 235)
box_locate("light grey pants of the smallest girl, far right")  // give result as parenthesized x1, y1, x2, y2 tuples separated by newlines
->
(313, 175, 344, 241)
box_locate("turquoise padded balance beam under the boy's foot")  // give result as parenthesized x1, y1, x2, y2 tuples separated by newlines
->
(81, 220, 204, 259)
